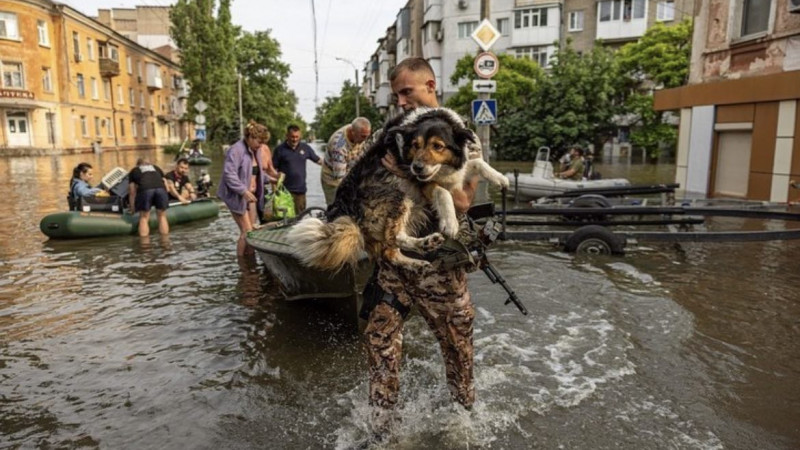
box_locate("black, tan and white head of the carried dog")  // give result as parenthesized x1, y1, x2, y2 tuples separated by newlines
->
(385, 113, 475, 182)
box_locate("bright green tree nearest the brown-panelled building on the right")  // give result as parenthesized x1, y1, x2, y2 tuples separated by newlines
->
(617, 20, 692, 160)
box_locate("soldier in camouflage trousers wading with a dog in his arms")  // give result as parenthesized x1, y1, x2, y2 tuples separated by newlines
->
(362, 58, 476, 417)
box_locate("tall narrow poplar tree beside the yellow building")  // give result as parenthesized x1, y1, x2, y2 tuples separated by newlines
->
(170, 0, 238, 141)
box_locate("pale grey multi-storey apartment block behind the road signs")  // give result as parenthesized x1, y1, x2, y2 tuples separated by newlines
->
(364, 0, 699, 106)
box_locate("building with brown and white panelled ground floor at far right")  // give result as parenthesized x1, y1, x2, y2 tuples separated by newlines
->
(654, 0, 800, 202)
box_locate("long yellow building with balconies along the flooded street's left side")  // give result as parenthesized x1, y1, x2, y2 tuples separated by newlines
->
(0, 0, 192, 155)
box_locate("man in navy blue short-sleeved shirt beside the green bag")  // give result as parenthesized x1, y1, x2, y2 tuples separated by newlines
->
(272, 125, 322, 214)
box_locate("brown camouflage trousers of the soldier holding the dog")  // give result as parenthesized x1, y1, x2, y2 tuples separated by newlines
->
(365, 262, 475, 408)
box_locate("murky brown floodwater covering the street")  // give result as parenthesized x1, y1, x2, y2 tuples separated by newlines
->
(0, 152, 800, 449)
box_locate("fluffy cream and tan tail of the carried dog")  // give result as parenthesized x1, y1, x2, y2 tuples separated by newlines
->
(287, 216, 364, 272)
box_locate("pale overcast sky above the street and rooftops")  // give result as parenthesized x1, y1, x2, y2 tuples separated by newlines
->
(60, 0, 407, 122)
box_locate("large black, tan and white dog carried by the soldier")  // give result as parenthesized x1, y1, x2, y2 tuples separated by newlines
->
(288, 108, 508, 271)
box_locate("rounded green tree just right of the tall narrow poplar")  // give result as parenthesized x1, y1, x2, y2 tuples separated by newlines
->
(228, 31, 304, 146)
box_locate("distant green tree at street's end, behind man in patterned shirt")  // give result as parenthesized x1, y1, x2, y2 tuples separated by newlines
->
(312, 80, 383, 142)
